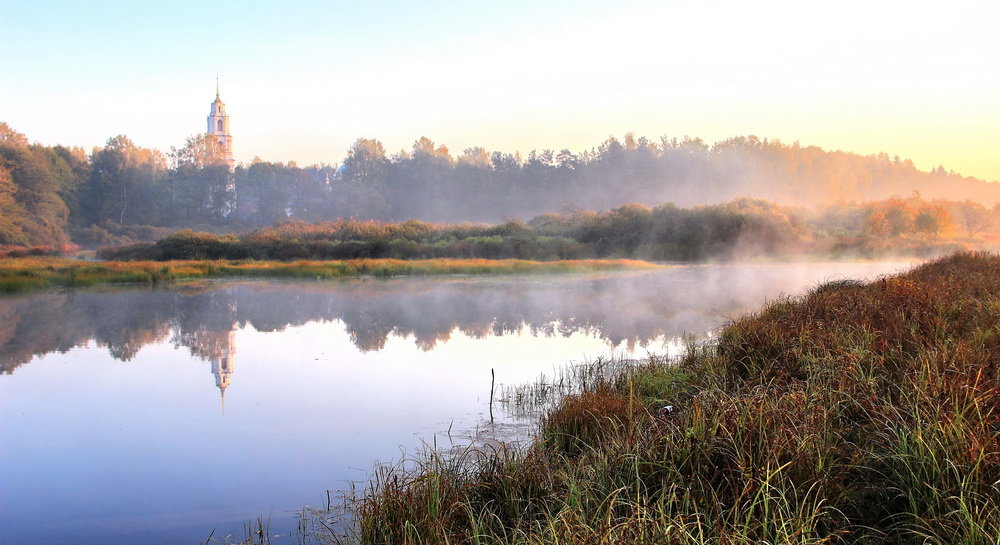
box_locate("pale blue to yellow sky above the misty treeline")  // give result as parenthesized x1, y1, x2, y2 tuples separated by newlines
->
(0, 0, 1000, 181)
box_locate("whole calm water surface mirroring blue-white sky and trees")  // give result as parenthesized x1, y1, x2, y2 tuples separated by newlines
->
(0, 264, 916, 544)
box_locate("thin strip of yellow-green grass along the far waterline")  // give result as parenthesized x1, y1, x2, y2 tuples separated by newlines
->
(0, 257, 657, 293)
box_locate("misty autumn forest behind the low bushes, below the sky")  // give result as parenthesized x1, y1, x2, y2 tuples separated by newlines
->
(0, 123, 1000, 245)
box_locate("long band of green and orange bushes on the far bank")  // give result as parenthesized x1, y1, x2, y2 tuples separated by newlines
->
(98, 208, 997, 262)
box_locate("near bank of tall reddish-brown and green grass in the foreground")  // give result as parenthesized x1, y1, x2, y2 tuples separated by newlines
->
(338, 254, 1000, 545)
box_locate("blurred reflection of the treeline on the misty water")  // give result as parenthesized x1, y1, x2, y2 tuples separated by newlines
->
(0, 267, 852, 373)
